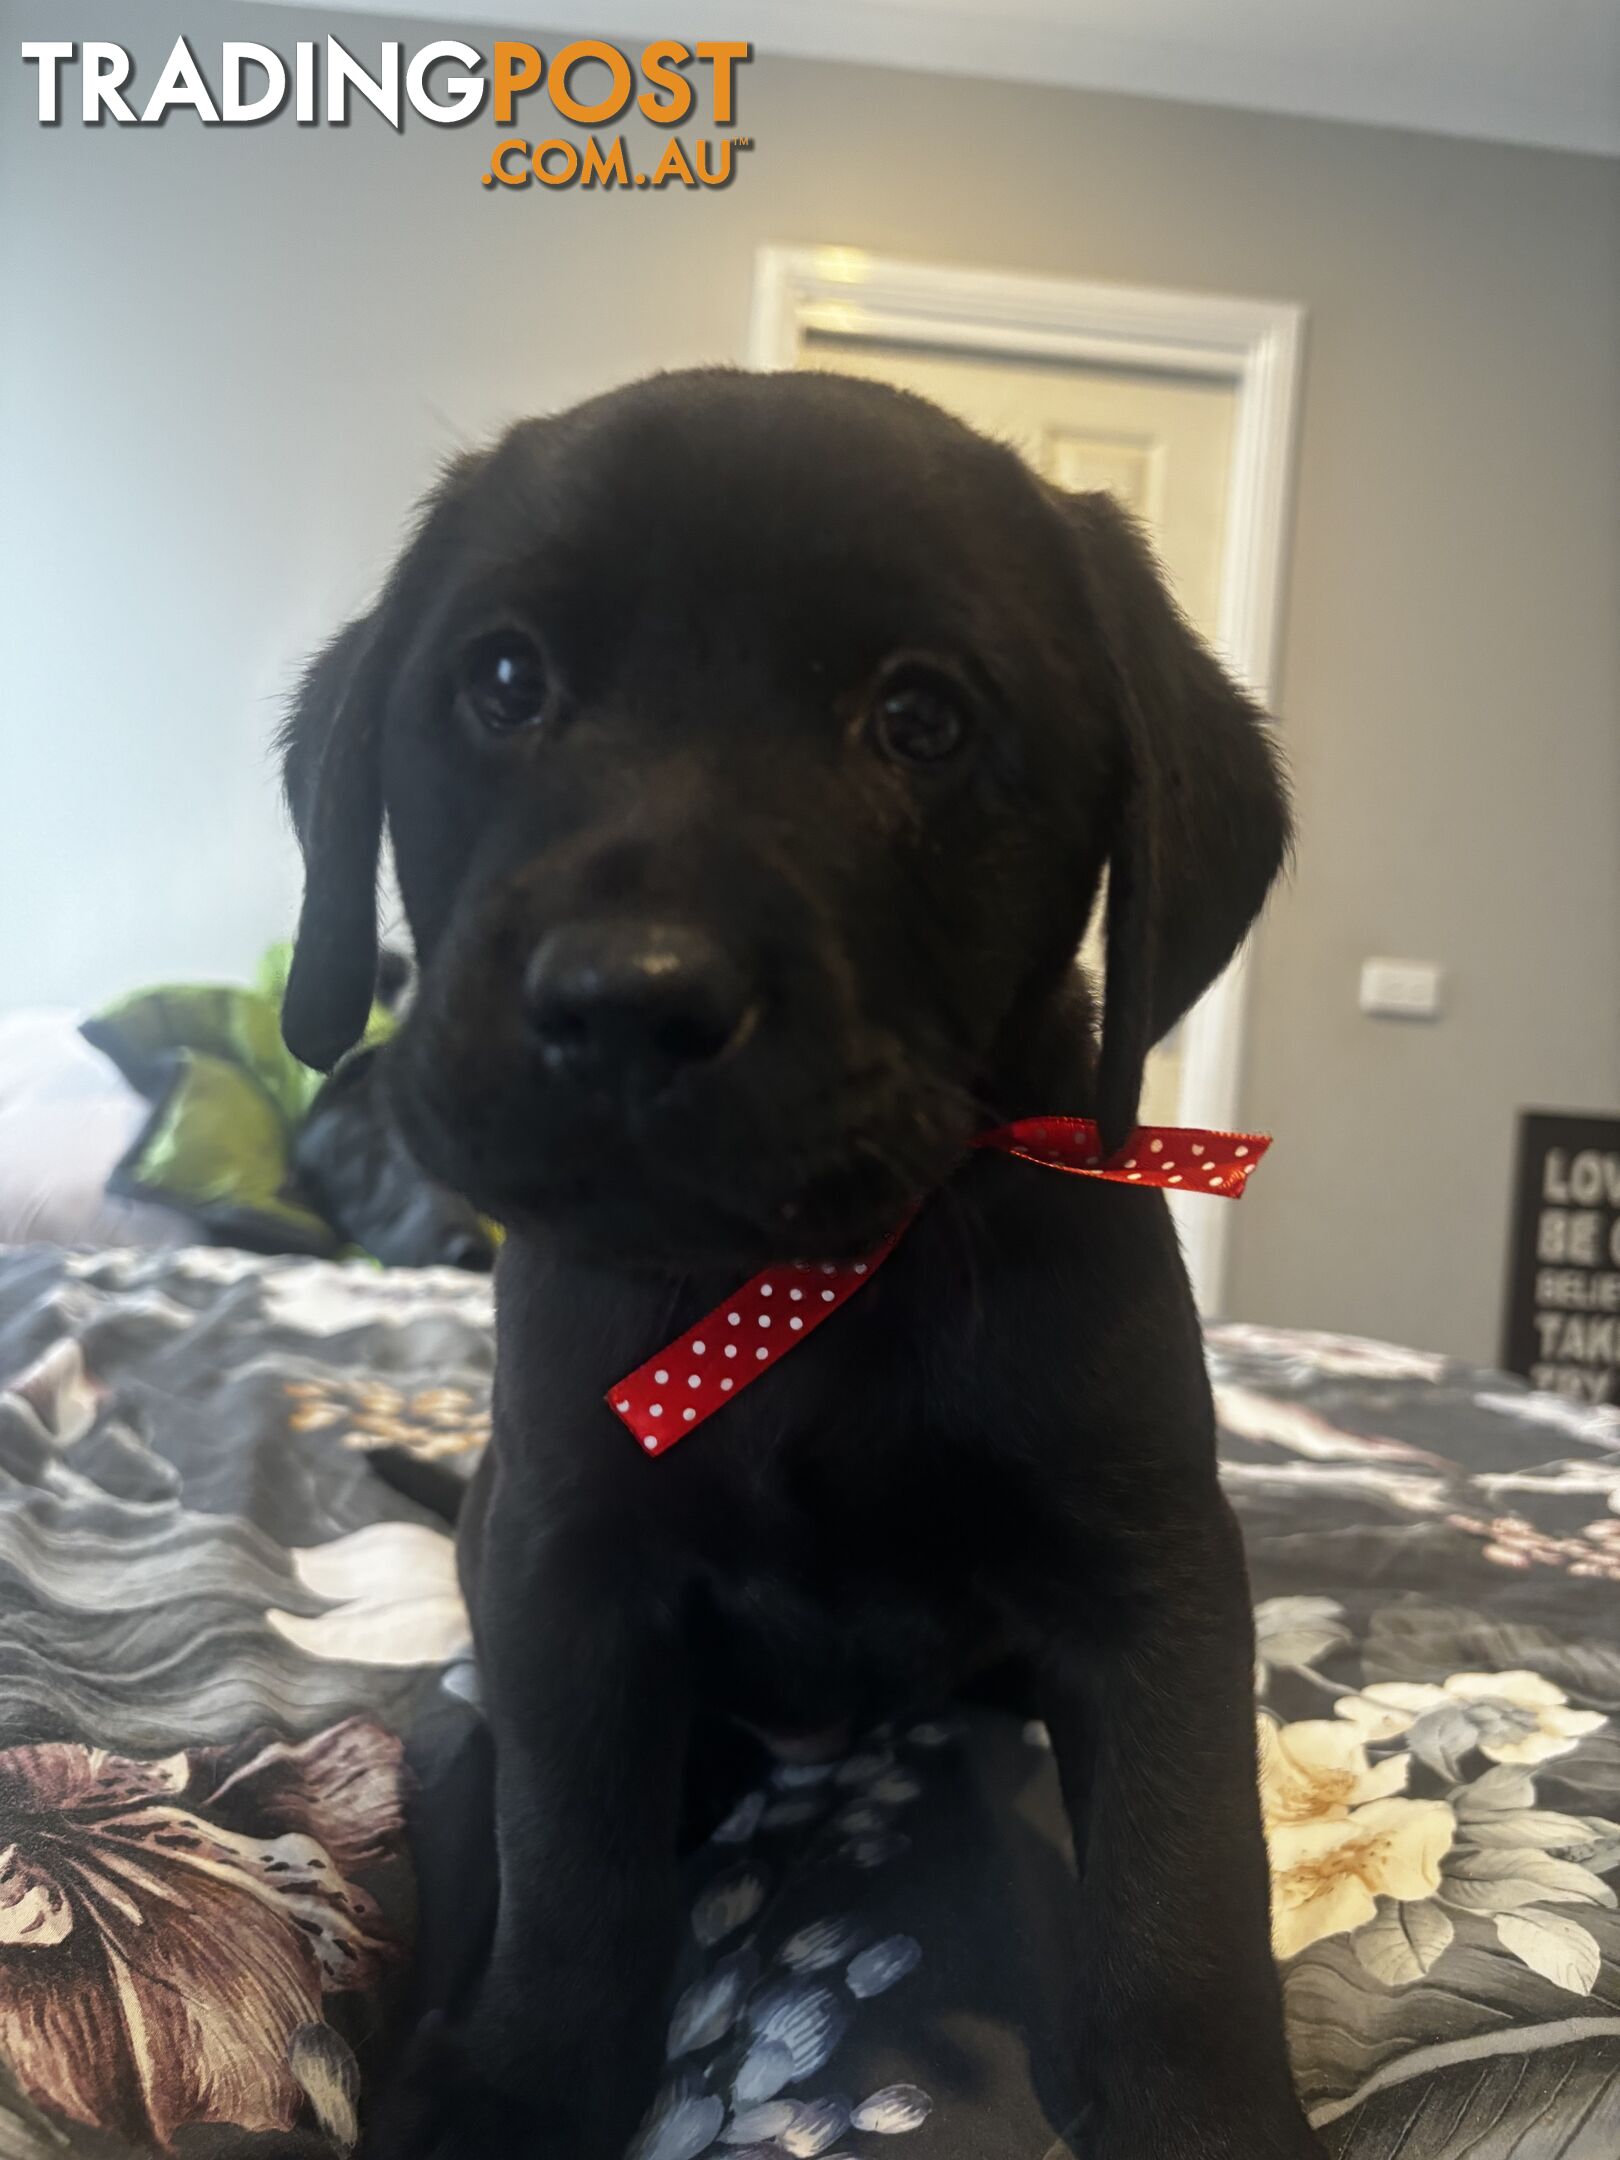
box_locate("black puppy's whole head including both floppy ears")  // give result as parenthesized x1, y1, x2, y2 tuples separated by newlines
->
(285, 372, 1287, 1264)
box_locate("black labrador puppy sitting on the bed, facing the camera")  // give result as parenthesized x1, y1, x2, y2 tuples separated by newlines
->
(285, 369, 1318, 2160)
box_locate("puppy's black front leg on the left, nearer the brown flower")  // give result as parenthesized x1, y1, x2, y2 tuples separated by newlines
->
(395, 1525, 689, 2160)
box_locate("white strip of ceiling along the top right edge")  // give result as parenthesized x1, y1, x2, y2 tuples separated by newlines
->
(257, 0, 1620, 156)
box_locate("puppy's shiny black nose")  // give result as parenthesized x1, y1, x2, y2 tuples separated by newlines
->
(523, 922, 750, 1091)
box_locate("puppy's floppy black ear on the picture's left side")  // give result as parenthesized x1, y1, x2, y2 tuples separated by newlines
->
(281, 607, 384, 1071)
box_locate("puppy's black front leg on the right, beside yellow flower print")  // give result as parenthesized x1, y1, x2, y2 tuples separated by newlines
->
(1043, 1482, 1320, 2160)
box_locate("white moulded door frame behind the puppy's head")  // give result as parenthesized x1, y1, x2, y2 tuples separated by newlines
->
(750, 246, 1305, 1318)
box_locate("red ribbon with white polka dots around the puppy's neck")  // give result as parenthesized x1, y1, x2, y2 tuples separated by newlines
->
(605, 1117, 1272, 1456)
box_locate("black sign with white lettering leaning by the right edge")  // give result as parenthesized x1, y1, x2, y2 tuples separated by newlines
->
(1501, 1110, 1620, 1402)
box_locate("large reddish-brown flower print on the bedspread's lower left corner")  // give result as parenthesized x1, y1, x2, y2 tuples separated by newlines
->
(0, 1717, 402, 2151)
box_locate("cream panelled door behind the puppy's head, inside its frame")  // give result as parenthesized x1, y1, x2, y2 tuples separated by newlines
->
(797, 328, 1238, 1125)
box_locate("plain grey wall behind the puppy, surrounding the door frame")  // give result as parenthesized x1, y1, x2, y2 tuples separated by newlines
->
(0, 0, 1620, 1354)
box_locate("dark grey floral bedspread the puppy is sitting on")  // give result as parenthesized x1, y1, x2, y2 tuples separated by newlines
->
(0, 1251, 1620, 2160)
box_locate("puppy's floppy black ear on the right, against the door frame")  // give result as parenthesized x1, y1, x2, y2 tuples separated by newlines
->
(1063, 492, 1290, 1147)
